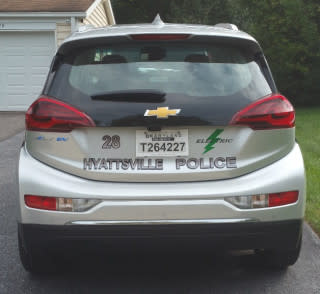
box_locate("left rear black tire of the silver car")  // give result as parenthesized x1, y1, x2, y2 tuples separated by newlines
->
(18, 228, 55, 274)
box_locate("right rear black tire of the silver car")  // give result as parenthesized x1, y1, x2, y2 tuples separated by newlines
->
(256, 237, 302, 269)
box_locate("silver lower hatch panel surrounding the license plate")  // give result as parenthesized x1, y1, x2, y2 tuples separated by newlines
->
(26, 126, 294, 182)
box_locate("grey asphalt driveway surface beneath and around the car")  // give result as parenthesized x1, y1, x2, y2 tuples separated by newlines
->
(0, 134, 320, 294)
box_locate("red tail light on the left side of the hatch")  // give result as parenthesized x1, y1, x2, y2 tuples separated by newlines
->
(26, 96, 95, 132)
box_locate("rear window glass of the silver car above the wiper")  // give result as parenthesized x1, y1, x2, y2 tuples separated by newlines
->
(48, 42, 272, 101)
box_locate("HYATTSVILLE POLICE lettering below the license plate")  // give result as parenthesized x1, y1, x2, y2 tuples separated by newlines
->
(83, 156, 237, 170)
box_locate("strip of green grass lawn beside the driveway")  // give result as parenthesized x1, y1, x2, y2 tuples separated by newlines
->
(296, 107, 320, 236)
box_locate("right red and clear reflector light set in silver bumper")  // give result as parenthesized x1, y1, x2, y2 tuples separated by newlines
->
(224, 191, 299, 209)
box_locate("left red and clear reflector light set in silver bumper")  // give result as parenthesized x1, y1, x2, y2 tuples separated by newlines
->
(24, 195, 101, 212)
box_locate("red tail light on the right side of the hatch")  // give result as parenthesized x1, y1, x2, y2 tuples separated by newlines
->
(230, 94, 295, 130)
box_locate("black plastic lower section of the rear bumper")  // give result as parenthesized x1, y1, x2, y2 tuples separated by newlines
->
(19, 220, 302, 252)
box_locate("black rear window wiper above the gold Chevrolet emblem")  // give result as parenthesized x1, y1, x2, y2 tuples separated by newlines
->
(91, 89, 166, 103)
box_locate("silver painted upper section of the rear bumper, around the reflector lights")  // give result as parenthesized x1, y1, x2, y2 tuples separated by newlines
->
(18, 144, 305, 226)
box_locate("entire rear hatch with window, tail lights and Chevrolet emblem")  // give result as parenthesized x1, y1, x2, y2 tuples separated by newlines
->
(26, 34, 295, 182)
